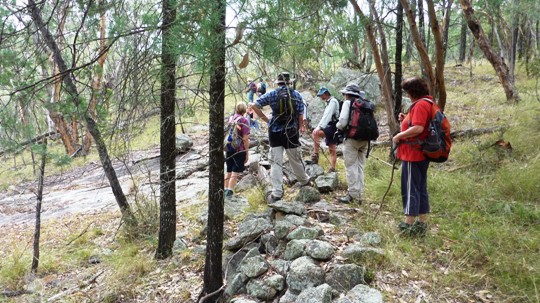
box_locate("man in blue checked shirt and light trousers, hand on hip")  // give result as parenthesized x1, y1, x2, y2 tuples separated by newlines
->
(250, 72, 310, 203)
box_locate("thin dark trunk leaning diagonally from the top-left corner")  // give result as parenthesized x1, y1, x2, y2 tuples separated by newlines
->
(28, 0, 135, 224)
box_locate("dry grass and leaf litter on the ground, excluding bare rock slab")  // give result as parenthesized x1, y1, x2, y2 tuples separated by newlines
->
(0, 64, 540, 302)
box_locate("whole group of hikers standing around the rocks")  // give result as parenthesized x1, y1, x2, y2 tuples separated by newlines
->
(225, 72, 433, 235)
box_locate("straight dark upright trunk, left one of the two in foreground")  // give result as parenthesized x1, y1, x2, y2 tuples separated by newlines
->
(156, 0, 177, 259)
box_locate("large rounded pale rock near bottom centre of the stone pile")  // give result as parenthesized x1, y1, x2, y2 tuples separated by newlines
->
(287, 257, 324, 291)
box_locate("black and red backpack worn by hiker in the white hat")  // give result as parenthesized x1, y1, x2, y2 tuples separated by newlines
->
(345, 97, 379, 141)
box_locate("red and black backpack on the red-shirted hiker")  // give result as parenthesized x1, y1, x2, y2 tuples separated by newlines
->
(409, 98, 452, 163)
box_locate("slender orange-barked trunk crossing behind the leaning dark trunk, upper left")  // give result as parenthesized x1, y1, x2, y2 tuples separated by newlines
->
(83, 0, 108, 155)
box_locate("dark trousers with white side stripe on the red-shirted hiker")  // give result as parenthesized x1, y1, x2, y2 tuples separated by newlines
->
(401, 160, 429, 217)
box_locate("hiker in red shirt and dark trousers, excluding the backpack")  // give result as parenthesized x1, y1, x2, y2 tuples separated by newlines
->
(392, 77, 433, 236)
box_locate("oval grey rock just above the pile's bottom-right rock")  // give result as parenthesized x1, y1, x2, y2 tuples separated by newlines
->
(326, 264, 366, 293)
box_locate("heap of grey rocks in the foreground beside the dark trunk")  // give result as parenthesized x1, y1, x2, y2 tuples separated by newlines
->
(224, 197, 384, 303)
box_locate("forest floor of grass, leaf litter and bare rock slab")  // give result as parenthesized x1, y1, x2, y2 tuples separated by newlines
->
(0, 66, 540, 303)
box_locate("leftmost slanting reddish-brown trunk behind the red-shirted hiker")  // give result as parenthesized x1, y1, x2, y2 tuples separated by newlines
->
(349, 0, 398, 133)
